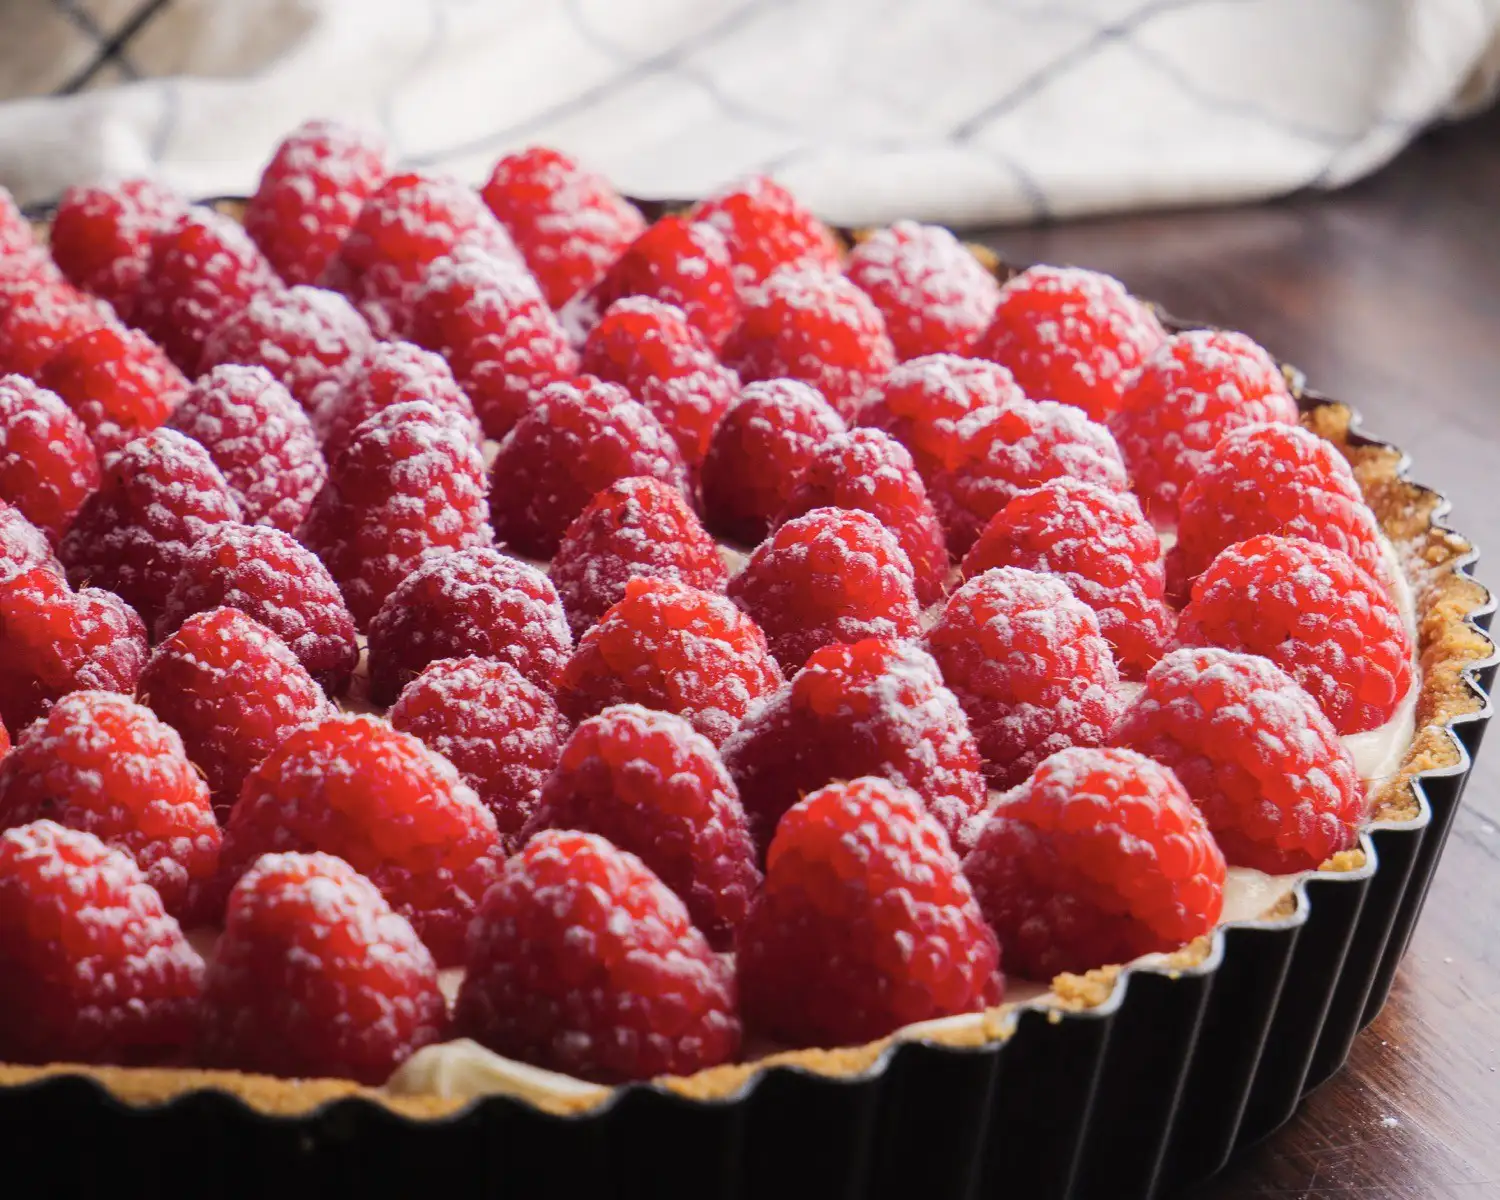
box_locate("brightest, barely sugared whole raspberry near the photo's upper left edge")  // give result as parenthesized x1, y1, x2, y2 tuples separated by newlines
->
(38, 326, 188, 455)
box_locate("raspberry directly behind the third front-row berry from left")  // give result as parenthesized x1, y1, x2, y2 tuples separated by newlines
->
(522, 704, 761, 951)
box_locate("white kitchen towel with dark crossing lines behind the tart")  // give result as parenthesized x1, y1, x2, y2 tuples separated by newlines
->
(0, 0, 1500, 225)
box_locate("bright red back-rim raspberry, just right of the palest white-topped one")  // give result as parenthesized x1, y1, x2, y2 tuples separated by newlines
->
(974, 266, 1167, 420)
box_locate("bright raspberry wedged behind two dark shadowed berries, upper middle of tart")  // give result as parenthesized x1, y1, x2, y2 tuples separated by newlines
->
(581, 296, 740, 468)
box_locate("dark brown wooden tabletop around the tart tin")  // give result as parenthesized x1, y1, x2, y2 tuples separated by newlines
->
(983, 111, 1500, 1200)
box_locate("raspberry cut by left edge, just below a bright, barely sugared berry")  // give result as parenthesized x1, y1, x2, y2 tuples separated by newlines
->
(0, 375, 99, 542)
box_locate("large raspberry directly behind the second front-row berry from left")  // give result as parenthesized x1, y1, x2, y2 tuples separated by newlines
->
(206, 716, 503, 966)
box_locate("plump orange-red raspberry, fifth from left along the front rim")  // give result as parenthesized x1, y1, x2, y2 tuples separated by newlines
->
(963, 747, 1224, 980)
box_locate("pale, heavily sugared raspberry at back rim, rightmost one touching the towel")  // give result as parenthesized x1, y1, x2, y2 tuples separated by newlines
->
(846, 221, 1001, 360)
